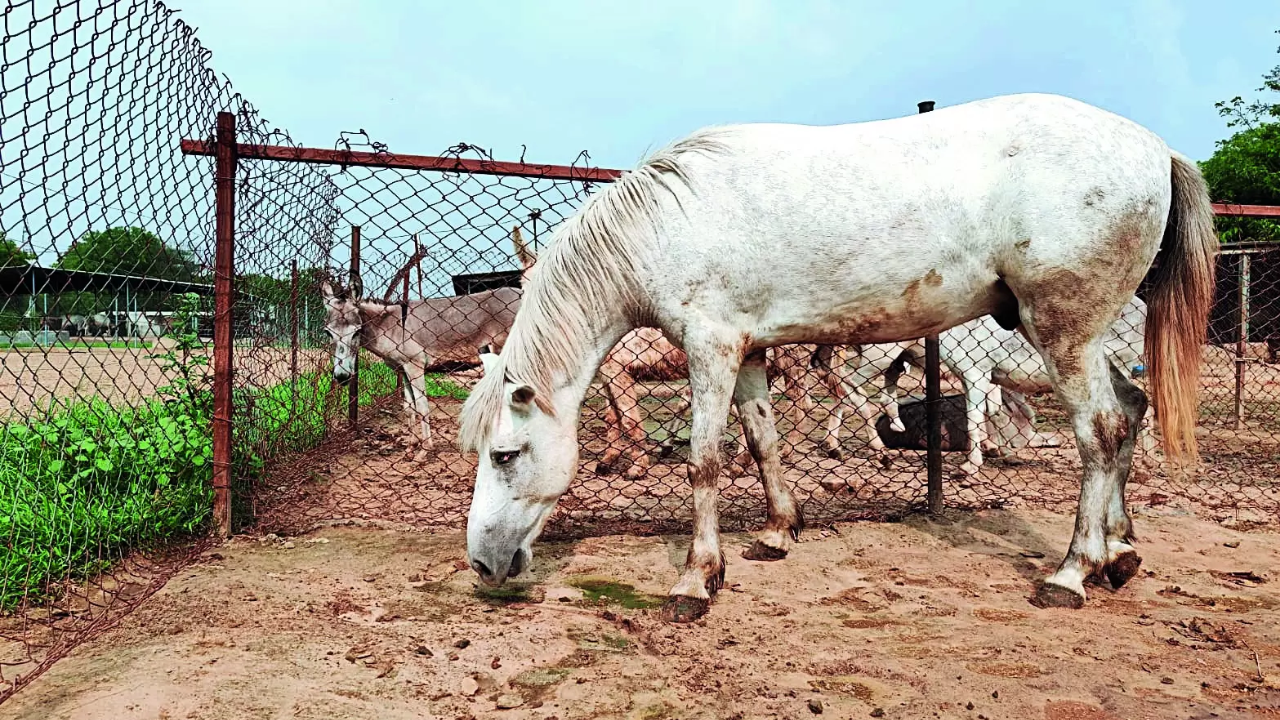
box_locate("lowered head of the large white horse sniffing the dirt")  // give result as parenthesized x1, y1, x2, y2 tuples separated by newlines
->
(467, 354, 577, 585)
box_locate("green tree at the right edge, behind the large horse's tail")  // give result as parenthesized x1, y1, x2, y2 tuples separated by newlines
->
(1201, 31, 1280, 241)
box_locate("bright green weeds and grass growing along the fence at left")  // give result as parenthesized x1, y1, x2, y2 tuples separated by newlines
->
(0, 345, 466, 612)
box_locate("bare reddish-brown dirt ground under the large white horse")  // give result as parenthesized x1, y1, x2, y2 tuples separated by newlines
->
(4, 510, 1280, 720)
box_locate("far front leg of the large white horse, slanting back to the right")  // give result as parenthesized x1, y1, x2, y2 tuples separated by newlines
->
(733, 351, 804, 560)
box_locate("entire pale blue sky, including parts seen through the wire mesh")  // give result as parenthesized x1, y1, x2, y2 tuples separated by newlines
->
(0, 0, 1280, 295)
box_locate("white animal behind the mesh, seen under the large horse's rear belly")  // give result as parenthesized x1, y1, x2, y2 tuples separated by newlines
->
(837, 296, 1153, 475)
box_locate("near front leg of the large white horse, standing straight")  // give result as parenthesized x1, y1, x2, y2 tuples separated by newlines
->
(662, 332, 742, 623)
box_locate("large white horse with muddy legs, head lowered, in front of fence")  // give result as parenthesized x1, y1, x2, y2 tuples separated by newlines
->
(460, 95, 1217, 621)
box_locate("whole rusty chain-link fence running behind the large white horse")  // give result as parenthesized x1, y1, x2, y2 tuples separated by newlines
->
(0, 1, 1280, 701)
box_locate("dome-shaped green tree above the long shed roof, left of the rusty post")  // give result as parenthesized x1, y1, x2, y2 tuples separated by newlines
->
(55, 228, 200, 282)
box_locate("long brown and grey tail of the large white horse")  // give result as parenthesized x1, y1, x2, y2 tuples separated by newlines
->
(1146, 152, 1217, 464)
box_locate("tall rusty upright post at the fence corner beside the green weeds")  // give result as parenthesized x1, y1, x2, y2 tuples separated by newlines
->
(212, 113, 236, 538)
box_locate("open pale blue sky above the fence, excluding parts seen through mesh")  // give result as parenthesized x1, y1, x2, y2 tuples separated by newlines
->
(173, 0, 1280, 167)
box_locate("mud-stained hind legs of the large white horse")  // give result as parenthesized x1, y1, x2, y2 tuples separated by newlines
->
(1023, 304, 1142, 607)
